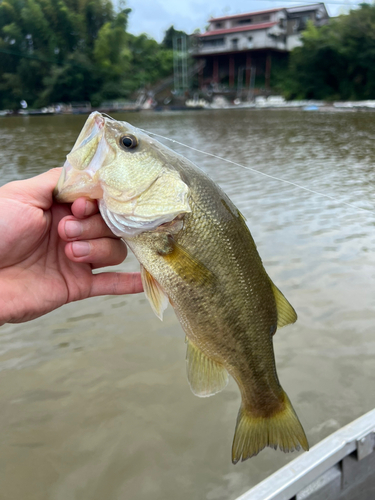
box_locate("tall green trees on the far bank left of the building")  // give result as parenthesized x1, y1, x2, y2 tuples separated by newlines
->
(0, 0, 173, 109)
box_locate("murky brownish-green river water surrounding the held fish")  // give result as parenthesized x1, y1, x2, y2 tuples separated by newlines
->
(0, 110, 375, 500)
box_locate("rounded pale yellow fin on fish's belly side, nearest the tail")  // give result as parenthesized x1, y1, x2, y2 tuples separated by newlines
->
(186, 339, 229, 398)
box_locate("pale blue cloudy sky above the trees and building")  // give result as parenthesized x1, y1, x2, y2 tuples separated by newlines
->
(126, 0, 360, 42)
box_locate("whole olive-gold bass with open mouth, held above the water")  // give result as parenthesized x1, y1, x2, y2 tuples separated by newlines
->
(54, 112, 309, 464)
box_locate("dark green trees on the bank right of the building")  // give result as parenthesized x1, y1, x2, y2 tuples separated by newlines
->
(281, 4, 375, 100)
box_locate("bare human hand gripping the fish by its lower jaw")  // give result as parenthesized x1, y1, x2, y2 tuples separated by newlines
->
(0, 168, 143, 325)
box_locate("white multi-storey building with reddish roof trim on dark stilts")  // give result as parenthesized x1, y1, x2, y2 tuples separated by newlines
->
(192, 3, 329, 92)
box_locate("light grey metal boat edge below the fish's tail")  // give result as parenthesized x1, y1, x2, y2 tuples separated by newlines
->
(237, 409, 375, 500)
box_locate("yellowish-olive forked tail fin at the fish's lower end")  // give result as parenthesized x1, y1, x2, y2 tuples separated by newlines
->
(232, 393, 309, 464)
